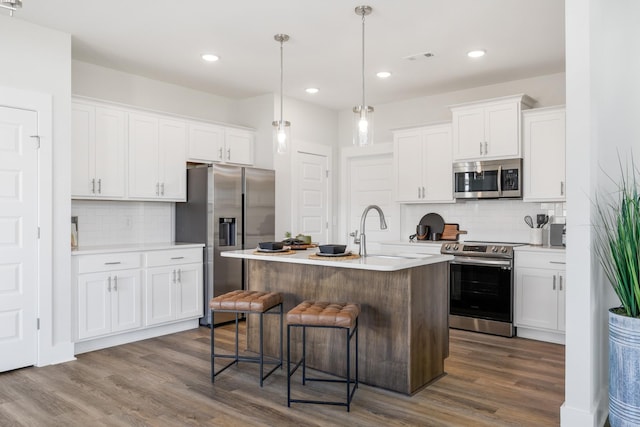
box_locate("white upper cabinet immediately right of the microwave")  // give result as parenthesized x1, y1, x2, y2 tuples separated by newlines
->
(522, 107, 566, 202)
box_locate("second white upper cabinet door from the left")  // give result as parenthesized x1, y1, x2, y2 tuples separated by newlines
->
(94, 107, 126, 198)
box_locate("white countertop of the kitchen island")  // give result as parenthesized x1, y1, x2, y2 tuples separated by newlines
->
(221, 249, 453, 271)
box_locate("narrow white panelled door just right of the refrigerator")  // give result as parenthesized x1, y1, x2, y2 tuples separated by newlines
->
(291, 151, 329, 243)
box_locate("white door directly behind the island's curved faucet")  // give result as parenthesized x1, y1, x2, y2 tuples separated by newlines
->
(346, 153, 400, 252)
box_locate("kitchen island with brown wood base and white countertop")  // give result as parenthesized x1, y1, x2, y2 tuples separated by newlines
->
(222, 249, 452, 395)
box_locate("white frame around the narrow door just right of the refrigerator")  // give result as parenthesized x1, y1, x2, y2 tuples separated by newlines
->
(290, 141, 334, 244)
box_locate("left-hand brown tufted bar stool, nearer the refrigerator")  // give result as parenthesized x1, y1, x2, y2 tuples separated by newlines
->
(209, 290, 283, 387)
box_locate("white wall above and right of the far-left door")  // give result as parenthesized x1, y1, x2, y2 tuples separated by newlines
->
(0, 15, 73, 364)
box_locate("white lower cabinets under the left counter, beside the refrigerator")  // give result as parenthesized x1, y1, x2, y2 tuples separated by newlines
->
(72, 247, 203, 348)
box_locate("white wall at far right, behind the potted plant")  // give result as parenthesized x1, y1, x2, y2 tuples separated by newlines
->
(561, 0, 640, 427)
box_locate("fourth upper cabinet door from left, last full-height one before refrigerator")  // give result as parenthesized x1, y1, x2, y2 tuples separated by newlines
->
(159, 119, 187, 201)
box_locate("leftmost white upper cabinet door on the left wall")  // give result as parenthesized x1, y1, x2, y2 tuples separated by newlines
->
(71, 103, 95, 197)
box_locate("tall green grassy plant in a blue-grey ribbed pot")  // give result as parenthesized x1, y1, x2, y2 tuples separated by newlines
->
(595, 164, 640, 427)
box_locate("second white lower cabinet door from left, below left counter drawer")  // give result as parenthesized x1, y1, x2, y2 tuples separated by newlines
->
(111, 270, 142, 332)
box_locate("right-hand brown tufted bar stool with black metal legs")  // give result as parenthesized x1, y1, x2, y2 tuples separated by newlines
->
(287, 301, 360, 412)
